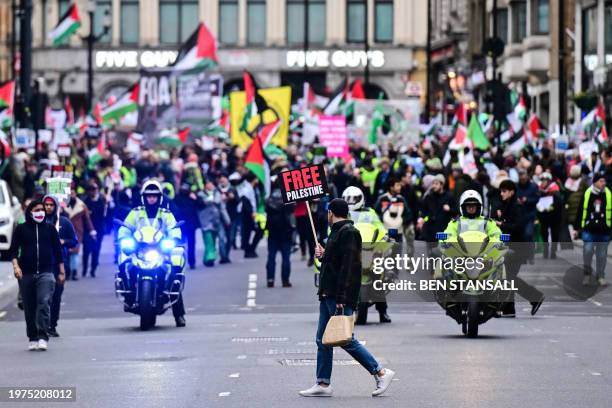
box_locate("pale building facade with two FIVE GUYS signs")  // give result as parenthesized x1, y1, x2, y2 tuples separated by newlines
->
(33, 0, 427, 110)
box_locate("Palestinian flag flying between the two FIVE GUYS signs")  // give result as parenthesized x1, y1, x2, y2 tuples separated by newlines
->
(172, 23, 219, 71)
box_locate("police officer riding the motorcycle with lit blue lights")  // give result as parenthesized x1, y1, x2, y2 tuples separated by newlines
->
(119, 180, 186, 327)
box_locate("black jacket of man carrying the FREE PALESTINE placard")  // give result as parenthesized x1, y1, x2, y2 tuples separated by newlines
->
(318, 220, 361, 308)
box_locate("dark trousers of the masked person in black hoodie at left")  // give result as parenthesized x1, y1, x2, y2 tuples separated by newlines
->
(19, 272, 55, 341)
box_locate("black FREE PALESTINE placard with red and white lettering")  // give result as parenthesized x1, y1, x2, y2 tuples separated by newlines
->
(279, 164, 328, 204)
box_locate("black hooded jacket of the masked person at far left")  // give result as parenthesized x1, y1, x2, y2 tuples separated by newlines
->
(9, 211, 63, 275)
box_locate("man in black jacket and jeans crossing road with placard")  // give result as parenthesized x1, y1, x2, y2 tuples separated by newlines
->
(300, 198, 395, 397)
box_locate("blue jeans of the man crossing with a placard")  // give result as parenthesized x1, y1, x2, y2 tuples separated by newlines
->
(316, 299, 382, 384)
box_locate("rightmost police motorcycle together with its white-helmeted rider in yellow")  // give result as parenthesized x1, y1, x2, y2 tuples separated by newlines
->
(434, 190, 510, 338)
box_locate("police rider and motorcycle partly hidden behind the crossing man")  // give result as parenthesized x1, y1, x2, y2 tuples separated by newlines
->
(314, 186, 398, 324)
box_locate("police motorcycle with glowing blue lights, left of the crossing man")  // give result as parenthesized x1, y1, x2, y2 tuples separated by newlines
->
(114, 182, 185, 330)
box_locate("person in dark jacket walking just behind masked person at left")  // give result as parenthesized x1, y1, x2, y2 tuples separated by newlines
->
(43, 195, 78, 337)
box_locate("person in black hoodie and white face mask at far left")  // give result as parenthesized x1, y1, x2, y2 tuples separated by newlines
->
(9, 200, 65, 351)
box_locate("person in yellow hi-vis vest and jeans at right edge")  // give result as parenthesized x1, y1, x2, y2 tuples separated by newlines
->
(575, 173, 612, 286)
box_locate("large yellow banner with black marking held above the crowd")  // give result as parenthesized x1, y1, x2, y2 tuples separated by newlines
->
(230, 86, 291, 148)
